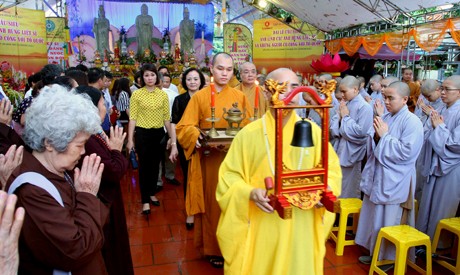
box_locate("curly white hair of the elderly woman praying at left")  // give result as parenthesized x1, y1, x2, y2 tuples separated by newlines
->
(23, 85, 101, 152)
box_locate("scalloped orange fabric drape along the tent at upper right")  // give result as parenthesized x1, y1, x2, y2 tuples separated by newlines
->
(325, 18, 460, 56)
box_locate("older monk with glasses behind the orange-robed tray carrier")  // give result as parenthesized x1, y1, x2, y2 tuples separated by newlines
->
(235, 62, 268, 118)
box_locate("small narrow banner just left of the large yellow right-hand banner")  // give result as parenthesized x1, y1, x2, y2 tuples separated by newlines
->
(224, 23, 252, 65)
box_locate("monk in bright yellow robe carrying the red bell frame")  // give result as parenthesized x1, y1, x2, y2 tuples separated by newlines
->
(216, 68, 342, 275)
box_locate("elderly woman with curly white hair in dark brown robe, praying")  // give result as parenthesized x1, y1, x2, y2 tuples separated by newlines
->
(7, 86, 108, 275)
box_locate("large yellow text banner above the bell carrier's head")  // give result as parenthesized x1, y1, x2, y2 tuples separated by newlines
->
(253, 18, 324, 77)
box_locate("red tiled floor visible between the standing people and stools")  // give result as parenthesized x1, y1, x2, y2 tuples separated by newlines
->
(122, 167, 450, 275)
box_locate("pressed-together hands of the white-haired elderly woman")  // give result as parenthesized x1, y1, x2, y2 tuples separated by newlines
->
(74, 154, 104, 196)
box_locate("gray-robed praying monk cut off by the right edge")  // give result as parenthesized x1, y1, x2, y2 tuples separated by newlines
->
(417, 75, 460, 248)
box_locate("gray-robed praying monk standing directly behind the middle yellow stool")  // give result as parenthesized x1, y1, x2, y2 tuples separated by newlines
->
(355, 81, 423, 264)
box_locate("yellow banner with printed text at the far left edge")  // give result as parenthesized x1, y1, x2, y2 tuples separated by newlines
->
(0, 8, 47, 74)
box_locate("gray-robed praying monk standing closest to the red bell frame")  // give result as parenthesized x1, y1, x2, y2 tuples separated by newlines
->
(331, 76, 373, 198)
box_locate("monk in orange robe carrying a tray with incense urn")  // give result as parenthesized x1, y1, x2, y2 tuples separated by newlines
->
(176, 53, 253, 266)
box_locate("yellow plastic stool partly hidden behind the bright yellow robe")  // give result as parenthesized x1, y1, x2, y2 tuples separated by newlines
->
(329, 198, 363, 256)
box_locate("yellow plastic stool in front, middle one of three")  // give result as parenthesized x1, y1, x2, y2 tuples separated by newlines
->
(369, 225, 431, 275)
